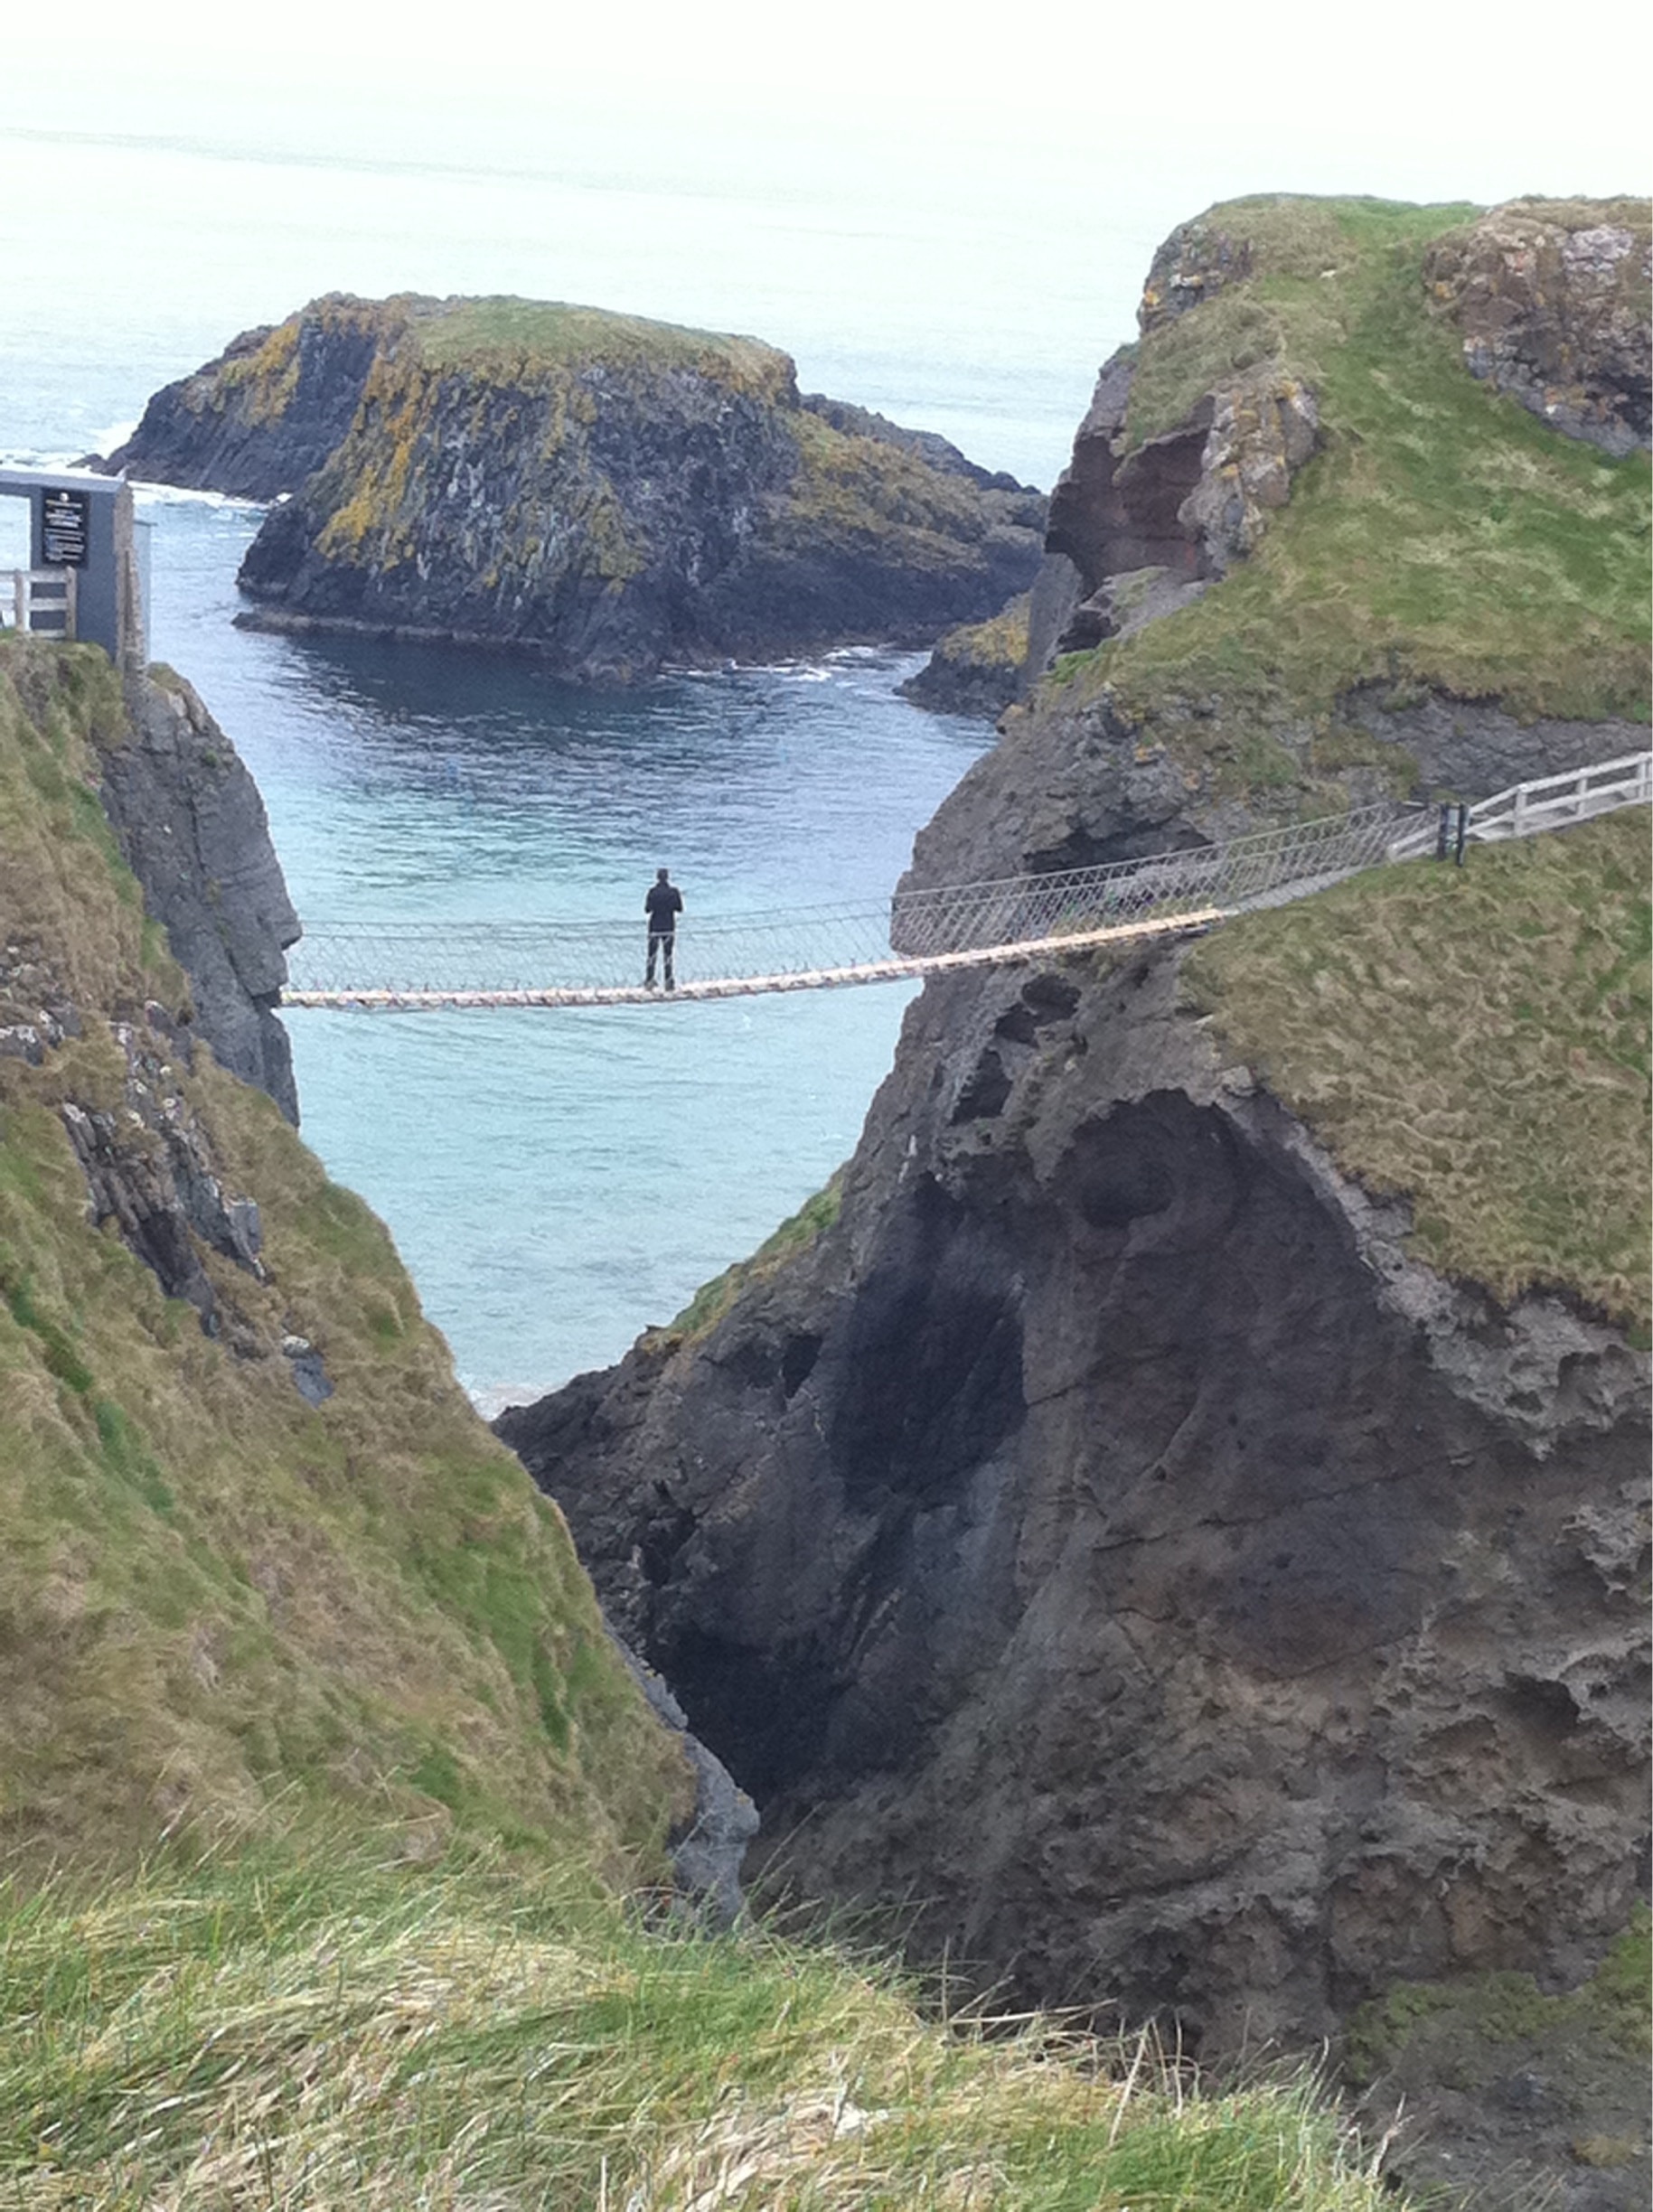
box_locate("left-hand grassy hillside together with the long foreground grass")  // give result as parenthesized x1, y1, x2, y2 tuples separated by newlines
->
(0, 643, 1424, 2212)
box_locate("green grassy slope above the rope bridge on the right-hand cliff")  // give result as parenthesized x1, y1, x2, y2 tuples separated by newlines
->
(1056, 199, 1648, 785)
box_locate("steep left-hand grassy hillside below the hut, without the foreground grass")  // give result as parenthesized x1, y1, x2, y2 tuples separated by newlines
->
(0, 646, 684, 1871)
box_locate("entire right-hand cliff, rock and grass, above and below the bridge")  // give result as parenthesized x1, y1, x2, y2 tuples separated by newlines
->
(498, 199, 1648, 2212)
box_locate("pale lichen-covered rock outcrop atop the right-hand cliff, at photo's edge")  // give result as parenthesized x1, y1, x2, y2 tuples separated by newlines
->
(1425, 199, 1653, 454)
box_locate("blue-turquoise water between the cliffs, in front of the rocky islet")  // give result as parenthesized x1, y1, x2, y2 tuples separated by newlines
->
(126, 493, 989, 1404)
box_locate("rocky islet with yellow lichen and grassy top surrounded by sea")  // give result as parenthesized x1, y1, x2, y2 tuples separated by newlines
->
(108, 296, 1045, 681)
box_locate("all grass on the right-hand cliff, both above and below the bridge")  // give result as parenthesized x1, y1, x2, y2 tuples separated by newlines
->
(1045, 199, 1648, 1334)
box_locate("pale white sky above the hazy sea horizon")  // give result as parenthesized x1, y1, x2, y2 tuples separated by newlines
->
(13, 0, 1653, 212)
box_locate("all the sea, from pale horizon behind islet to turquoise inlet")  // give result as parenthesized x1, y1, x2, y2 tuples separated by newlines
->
(0, 86, 1164, 1404)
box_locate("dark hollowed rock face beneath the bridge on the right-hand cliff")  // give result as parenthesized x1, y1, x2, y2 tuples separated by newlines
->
(498, 956, 1647, 2048)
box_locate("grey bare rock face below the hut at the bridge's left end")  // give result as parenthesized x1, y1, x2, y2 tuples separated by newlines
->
(102, 677, 299, 1124)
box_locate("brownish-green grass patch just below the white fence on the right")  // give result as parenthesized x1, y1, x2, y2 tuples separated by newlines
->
(1184, 808, 1653, 1340)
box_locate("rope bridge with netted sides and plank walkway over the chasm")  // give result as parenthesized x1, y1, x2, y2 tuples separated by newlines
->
(281, 805, 1418, 1011)
